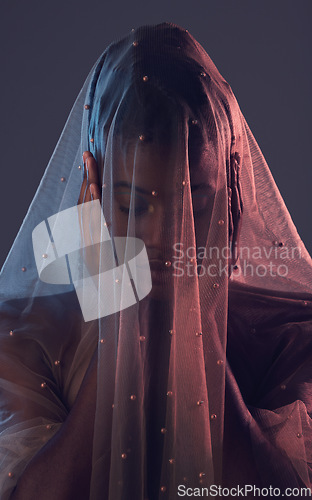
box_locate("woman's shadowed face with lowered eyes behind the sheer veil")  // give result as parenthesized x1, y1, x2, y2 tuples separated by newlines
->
(104, 131, 215, 298)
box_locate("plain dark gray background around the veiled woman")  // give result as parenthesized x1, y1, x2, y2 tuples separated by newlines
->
(0, 0, 312, 266)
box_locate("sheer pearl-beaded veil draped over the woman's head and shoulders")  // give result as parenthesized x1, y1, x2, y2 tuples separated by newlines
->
(0, 23, 312, 500)
